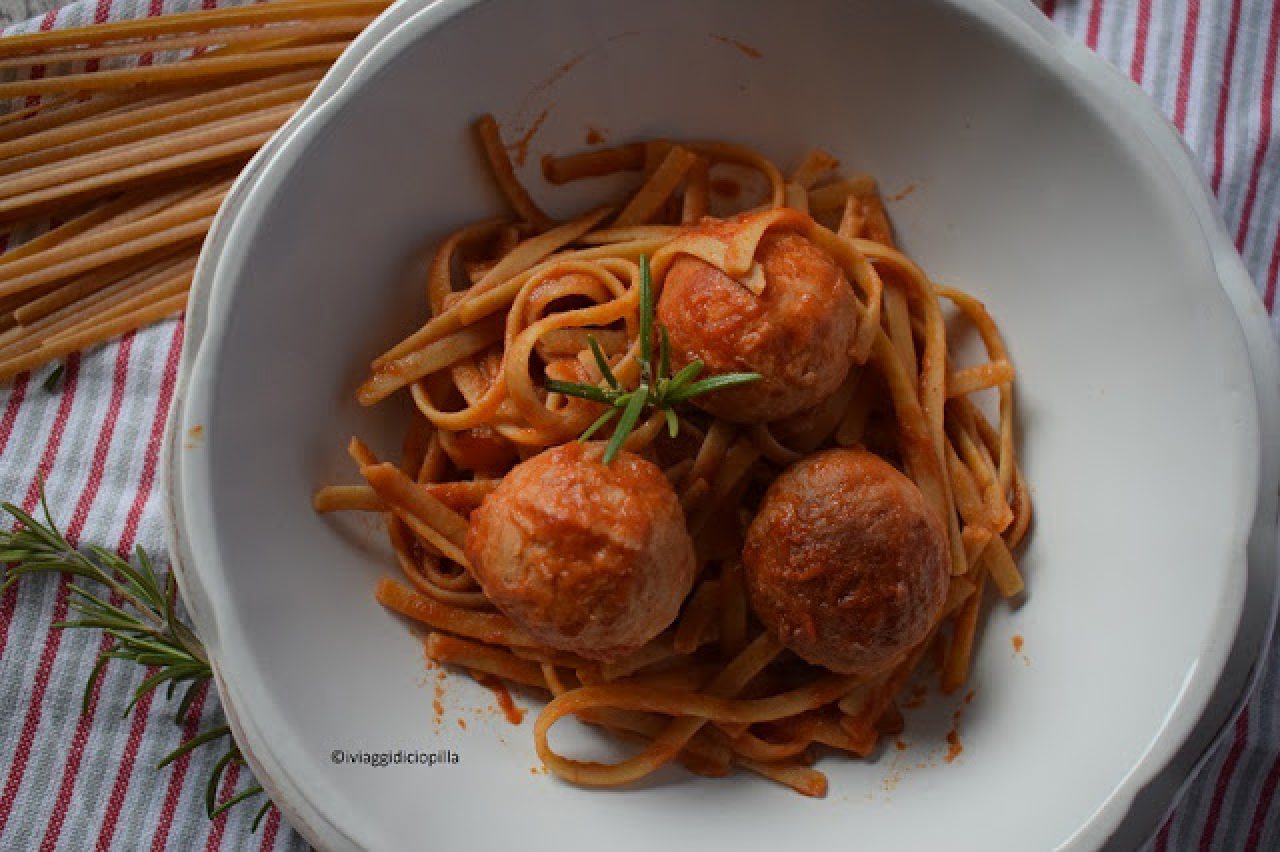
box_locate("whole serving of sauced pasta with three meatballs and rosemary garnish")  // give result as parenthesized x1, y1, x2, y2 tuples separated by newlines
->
(315, 116, 1032, 796)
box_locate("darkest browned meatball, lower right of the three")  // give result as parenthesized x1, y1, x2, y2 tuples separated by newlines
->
(742, 449, 951, 675)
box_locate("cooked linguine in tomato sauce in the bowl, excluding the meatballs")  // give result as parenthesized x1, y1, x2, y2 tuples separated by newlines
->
(315, 116, 1032, 796)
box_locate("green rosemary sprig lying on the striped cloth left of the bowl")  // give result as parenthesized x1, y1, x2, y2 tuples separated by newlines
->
(0, 485, 271, 830)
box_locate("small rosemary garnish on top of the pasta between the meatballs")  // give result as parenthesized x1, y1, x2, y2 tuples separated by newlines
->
(547, 255, 760, 464)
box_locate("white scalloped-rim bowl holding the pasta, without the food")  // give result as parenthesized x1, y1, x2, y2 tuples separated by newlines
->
(166, 0, 1280, 849)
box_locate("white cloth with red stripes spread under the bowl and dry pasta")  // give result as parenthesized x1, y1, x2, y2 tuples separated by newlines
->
(0, 0, 1280, 851)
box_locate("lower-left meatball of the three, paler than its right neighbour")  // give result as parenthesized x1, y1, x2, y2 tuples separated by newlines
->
(466, 441, 695, 660)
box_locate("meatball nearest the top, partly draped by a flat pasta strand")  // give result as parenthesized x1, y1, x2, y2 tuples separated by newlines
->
(658, 223, 858, 422)
